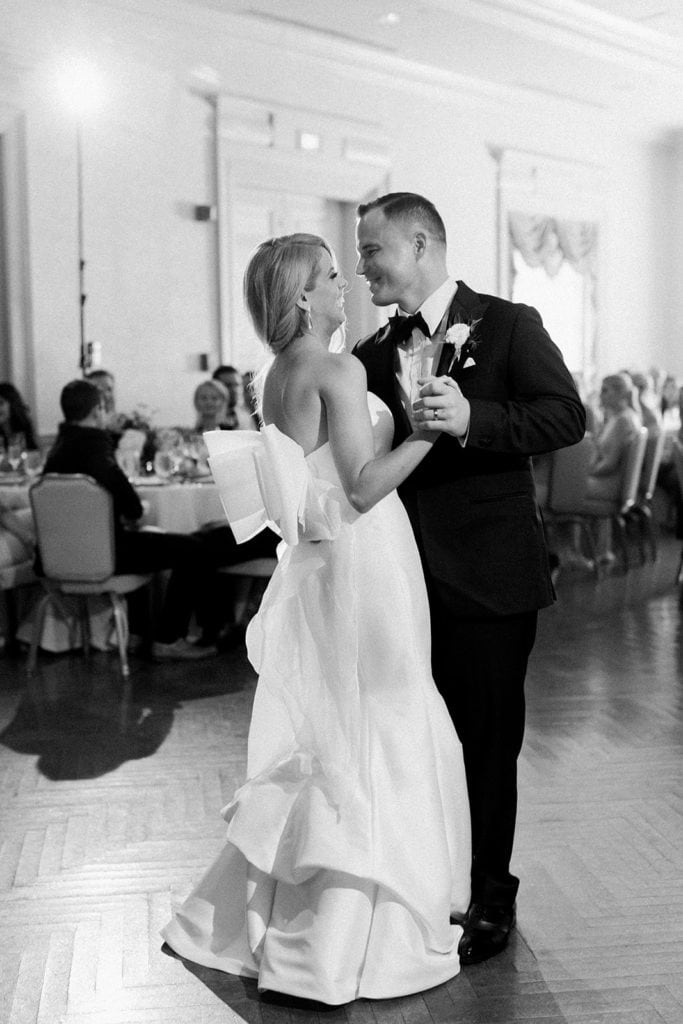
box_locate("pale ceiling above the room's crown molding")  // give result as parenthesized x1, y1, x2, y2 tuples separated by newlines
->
(180, 0, 683, 132)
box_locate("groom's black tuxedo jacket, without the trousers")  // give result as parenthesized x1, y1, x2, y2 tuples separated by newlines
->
(354, 282, 586, 615)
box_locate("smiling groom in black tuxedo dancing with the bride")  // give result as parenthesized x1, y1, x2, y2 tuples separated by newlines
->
(354, 193, 585, 964)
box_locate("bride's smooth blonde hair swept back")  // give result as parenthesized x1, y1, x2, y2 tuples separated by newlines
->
(244, 233, 332, 355)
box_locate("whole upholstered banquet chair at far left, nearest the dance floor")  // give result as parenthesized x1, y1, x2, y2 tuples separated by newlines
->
(27, 473, 152, 677)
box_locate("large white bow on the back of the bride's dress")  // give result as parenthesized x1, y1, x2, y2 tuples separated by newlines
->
(204, 424, 341, 547)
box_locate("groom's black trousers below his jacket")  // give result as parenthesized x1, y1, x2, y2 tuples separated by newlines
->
(430, 587, 538, 907)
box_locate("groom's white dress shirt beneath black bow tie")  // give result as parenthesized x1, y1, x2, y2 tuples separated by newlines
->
(396, 278, 458, 429)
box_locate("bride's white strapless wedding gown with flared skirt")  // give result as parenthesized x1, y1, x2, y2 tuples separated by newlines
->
(163, 395, 470, 1004)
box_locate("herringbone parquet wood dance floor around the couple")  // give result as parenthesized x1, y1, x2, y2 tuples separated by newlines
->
(0, 541, 683, 1024)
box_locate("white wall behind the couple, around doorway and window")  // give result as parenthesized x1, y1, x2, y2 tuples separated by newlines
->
(0, 0, 683, 432)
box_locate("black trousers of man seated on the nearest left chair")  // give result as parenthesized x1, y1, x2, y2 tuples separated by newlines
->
(116, 529, 214, 643)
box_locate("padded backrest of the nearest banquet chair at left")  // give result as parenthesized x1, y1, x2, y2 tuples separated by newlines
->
(29, 473, 116, 583)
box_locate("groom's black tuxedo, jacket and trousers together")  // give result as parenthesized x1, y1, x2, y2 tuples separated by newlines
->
(353, 282, 585, 910)
